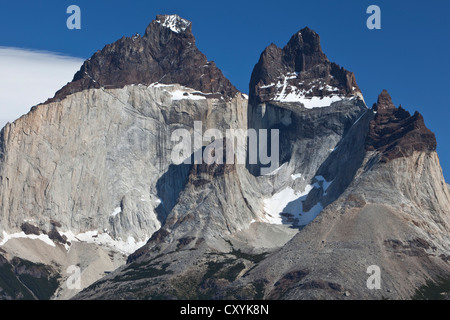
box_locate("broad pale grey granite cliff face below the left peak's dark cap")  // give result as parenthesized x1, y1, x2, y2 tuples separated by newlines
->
(0, 85, 245, 241)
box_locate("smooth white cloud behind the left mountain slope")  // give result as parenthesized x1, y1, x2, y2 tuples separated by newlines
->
(0, 46, 83, 129)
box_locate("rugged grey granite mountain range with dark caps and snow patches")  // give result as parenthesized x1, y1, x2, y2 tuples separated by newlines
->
(0, 15, 450, 300)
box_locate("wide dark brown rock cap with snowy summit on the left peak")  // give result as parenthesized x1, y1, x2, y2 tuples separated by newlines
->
(47, 15, 238, 102)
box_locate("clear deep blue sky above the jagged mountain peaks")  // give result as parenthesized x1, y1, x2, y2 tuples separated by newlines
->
(0, 0, 450, 181)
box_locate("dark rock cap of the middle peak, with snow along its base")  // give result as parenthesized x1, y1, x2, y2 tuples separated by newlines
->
(249, 27, 360, 104)
